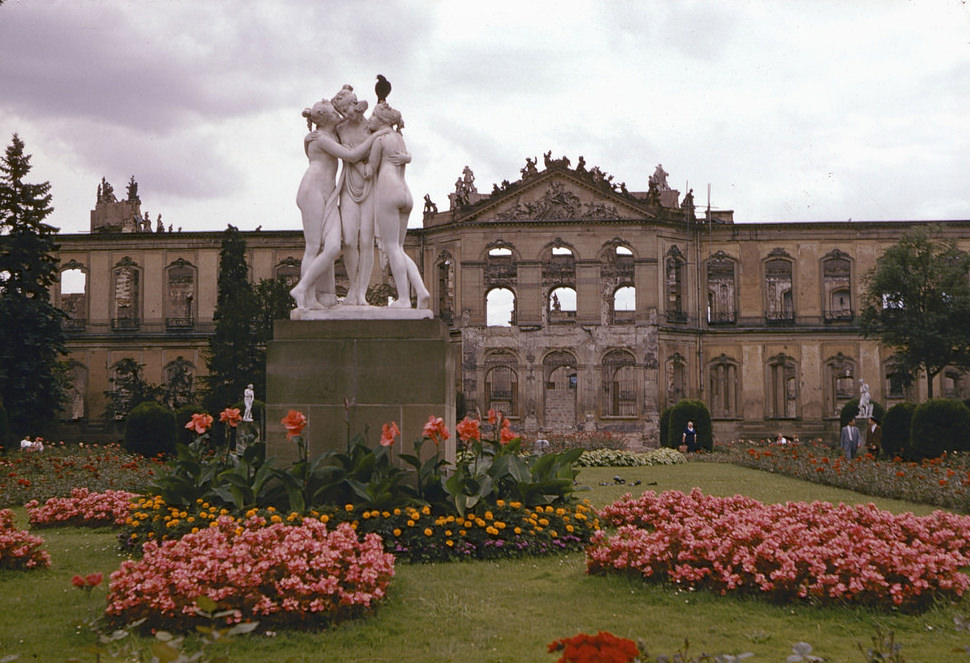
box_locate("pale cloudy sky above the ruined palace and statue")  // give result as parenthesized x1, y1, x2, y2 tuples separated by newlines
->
(0, 0, 970, 232)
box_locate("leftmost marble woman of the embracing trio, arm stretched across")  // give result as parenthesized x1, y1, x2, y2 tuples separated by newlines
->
(290, 99, 390, 310)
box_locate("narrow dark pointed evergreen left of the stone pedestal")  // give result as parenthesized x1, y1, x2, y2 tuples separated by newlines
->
(204, 225, 266, 412)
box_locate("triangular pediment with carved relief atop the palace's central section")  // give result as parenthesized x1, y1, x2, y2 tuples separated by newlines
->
(460, 173, 652, 222)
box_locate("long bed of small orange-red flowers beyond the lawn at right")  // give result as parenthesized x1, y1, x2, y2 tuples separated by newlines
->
(728, 443, 970, 513)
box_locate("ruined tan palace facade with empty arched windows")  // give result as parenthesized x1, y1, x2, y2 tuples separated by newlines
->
(56, 154, 970, 447)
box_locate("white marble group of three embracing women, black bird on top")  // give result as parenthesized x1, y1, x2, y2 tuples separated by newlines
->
(290, 77, 430, 317)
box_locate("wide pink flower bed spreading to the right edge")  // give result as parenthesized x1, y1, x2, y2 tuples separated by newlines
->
(586, 488, 970, 608)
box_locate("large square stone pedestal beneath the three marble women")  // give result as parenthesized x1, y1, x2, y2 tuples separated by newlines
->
(266, 319, 455, 466)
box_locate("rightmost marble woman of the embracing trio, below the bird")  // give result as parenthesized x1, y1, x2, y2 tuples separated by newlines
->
(364, 103, 431, 309)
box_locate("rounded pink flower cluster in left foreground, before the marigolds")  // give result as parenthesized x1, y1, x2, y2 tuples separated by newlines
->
(106, 516, 394, 628)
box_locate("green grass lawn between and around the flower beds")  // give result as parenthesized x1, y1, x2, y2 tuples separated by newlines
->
(0, 463, 970, 663)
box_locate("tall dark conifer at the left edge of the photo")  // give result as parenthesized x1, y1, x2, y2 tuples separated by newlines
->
(0, 134, 67, 435)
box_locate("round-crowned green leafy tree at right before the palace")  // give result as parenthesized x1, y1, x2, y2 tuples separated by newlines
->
(861, 228, 970, 398)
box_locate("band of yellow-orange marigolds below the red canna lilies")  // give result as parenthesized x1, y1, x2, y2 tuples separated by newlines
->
(119, 497, 599, 562)
